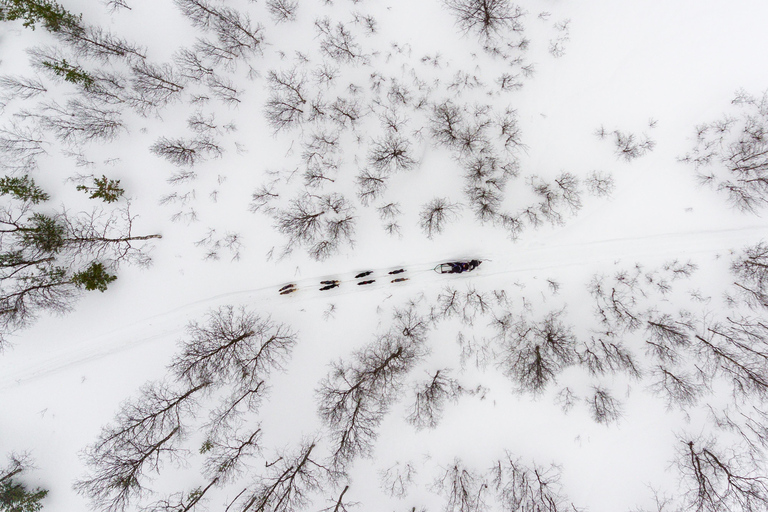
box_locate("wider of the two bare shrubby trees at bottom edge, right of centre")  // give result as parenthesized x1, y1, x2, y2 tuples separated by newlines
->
(491, 452, 575, 512)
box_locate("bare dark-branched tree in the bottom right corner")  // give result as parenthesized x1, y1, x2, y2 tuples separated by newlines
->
(677, 437, 768, 512)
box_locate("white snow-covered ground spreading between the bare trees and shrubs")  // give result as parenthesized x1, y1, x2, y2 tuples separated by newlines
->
(0, 0, 768, 512)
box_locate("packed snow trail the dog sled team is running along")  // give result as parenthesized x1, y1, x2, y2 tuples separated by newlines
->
(0, 225, 768, 390)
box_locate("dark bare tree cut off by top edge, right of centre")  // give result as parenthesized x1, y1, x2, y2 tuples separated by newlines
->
(445, 0, 525, 41)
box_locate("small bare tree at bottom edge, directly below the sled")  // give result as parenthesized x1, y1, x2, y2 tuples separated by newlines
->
(434, 459, 488, 512)
